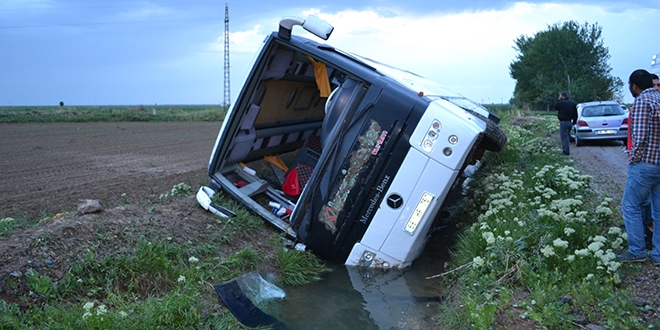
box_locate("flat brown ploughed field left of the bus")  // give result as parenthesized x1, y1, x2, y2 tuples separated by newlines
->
(0, 122, 220, 218)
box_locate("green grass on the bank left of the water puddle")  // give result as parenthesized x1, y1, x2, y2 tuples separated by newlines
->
(0, 184, 327, 329)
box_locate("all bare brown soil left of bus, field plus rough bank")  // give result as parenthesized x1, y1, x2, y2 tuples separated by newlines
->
(0, 122, 278, 308)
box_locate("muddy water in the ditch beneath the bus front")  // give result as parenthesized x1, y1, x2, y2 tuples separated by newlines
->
(276, 222, 451, 330)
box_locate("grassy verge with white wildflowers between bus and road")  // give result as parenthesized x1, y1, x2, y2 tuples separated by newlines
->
(436, 112, 657, 329)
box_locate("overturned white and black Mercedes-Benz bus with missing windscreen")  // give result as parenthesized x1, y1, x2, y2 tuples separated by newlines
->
(197, 17, 507, 268)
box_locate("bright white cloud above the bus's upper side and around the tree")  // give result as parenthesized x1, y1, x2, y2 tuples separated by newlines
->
(251, 2, 660, 102)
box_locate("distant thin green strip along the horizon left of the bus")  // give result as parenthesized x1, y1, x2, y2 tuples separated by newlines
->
(0, 105, 227, 123)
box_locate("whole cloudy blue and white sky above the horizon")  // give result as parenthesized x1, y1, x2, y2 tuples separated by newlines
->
(0, 0, 660, 106)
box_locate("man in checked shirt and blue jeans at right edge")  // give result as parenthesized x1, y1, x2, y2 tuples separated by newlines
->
(616, 70, 660, 266)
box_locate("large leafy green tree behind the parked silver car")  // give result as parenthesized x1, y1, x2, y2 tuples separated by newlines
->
(509, 21, 623, 108)
